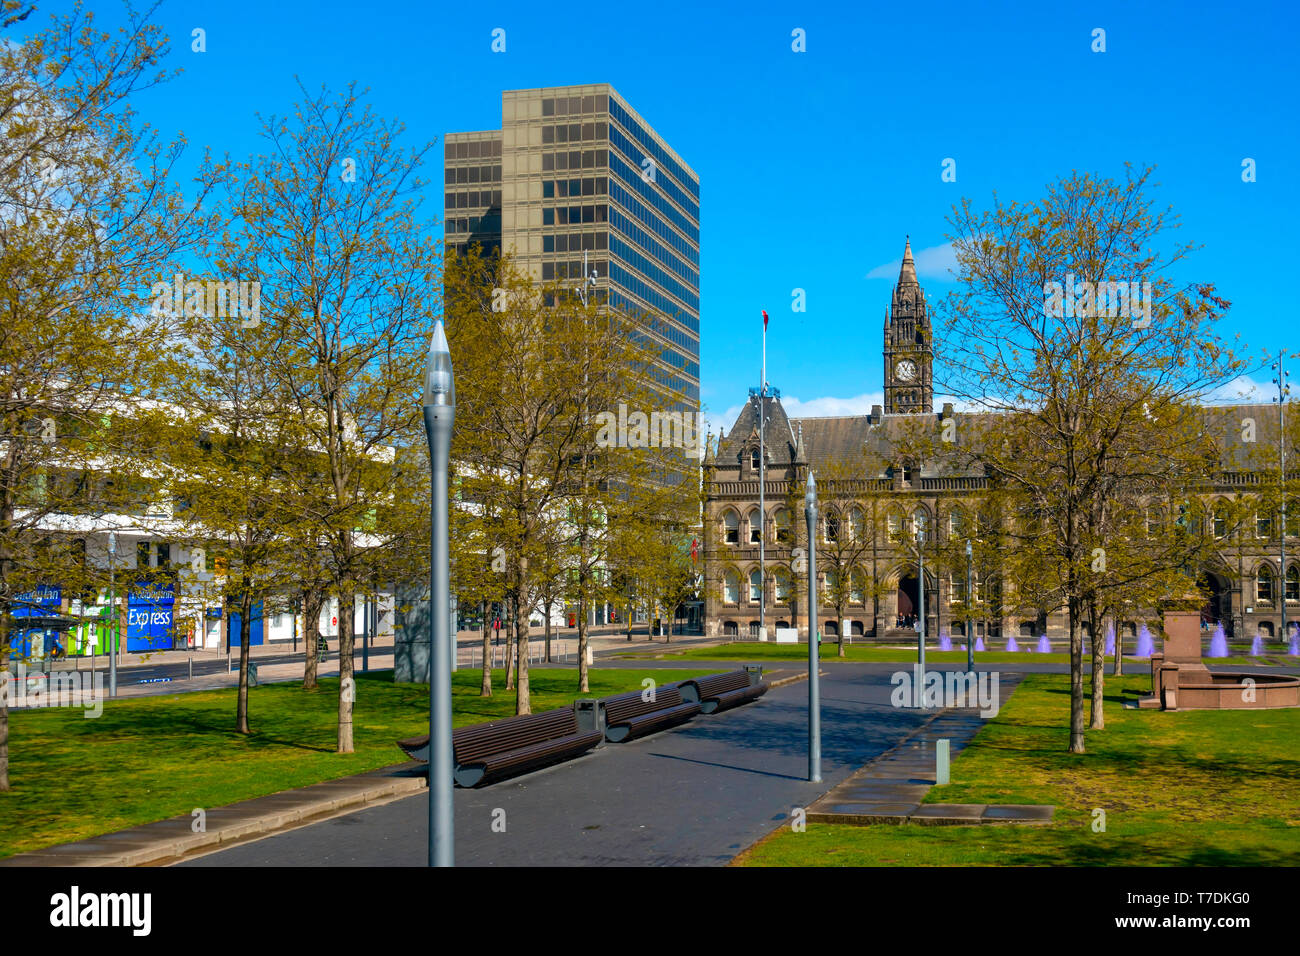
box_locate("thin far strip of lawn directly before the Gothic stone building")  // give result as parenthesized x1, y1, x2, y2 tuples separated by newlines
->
(619, 639, 1300, 675)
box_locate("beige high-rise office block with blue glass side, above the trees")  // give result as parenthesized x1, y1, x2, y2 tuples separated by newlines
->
(445, 83, 699, 410)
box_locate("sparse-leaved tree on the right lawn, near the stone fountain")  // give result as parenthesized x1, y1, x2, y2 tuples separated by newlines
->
(939, 169, 1242, 753)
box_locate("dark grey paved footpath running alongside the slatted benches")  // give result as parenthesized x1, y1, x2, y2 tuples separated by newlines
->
(181, 663, 993, 866)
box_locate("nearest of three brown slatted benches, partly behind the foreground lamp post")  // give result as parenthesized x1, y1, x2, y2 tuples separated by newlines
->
(398, 708, 601, 787)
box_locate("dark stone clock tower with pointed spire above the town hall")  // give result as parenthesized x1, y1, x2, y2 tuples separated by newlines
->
(885, 237, 935, 415)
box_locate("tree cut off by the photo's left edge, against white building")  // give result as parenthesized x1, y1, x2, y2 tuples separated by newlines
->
(0, 1, 207, 791)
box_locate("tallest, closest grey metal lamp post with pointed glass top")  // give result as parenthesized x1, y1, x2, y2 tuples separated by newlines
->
(424, 319, 456, 866)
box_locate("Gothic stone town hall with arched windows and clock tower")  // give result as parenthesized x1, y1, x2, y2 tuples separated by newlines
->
(702, 241, 1300, 649)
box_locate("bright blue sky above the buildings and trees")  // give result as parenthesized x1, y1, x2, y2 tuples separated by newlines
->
(25, 0, 1300, 427)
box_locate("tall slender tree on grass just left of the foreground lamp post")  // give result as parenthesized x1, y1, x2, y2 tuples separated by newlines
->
(215, 86, 439, 753)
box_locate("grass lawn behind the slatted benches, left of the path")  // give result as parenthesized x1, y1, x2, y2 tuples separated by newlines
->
(0, 667, 709, 857)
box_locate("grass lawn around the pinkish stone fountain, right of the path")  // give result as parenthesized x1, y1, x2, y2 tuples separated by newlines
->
(738, 674, 1300, 866)
